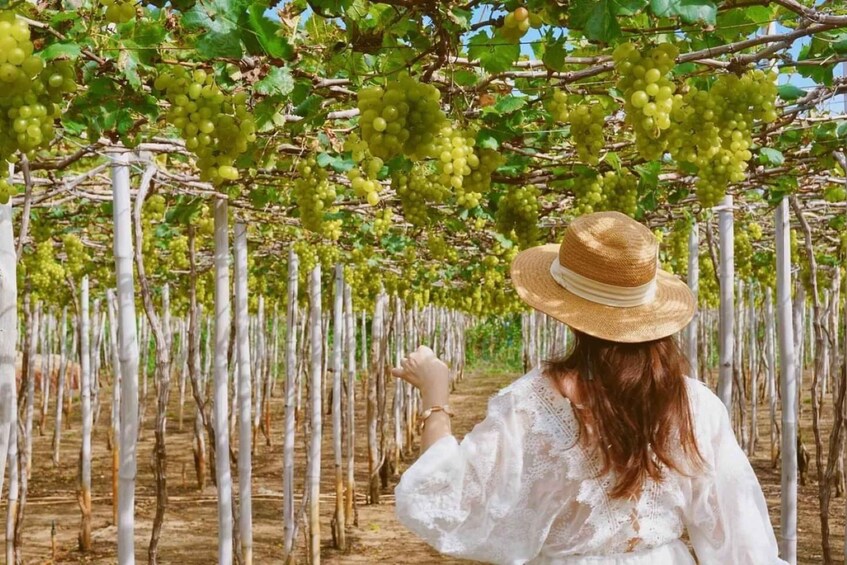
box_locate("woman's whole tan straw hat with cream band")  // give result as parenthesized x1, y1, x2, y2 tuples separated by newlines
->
(512, 212, 696, 343)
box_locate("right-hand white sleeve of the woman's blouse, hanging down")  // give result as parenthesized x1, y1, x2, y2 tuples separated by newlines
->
(685, 378, 786, 565)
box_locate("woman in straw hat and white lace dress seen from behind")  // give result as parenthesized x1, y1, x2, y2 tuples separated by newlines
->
(394, 212, 785, 565)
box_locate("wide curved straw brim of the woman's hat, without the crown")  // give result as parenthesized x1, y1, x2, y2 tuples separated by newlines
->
(511, 244, 697, 343)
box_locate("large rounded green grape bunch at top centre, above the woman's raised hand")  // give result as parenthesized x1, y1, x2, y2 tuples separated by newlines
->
(358, 73, 447, 161)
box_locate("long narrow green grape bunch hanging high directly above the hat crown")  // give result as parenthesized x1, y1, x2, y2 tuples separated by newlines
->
(612, 43, 679, 160)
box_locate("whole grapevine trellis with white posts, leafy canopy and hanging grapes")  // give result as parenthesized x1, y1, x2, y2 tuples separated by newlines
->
(0, 0, 847, 564)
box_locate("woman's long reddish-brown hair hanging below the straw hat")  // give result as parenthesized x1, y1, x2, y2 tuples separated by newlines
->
(544, 332, 703, 498)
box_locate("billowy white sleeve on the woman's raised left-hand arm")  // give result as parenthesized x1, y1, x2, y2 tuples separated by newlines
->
(395, 388, 543, 564)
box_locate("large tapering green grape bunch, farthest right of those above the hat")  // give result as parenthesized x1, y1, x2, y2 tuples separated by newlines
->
(668, 70, 778, 207)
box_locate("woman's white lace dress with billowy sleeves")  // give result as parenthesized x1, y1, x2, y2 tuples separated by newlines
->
(395, 370, 785, 565)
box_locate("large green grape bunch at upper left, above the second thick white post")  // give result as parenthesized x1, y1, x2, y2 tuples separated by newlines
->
(153, 66, 256, 185)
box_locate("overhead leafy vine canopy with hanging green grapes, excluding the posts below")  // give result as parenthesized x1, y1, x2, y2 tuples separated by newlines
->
(0, 0, 847, 312)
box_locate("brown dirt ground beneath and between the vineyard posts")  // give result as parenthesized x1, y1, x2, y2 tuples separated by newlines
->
(8, 372, 845, 564)
